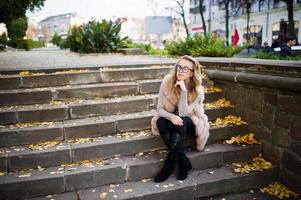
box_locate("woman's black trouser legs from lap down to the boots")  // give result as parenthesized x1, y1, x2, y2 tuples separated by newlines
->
(157, 117, 195, 154)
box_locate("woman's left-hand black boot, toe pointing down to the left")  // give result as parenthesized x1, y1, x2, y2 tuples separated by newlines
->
(154, 151, 177, 183)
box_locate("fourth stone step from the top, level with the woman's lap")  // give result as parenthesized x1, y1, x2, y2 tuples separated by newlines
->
(0, 108, 239, 147)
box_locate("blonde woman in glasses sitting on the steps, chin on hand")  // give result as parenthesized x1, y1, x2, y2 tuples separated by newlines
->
(152, 55, 209, 182)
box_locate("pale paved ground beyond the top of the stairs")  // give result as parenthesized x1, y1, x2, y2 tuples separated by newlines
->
(0, 48, 175, 71)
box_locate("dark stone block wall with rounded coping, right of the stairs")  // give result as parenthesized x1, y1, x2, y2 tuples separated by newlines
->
(205, 61, 301, 193)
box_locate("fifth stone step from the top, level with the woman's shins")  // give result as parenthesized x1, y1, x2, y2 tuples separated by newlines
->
(0, 123, 247, 171)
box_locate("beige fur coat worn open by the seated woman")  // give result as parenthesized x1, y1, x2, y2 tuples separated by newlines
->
(151, 74, 209, 151)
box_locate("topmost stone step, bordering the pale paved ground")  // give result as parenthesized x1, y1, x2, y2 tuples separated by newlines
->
(0, 65, 172, 90)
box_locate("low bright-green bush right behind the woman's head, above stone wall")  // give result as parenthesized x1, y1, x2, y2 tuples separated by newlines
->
(166, 35, 242, 57)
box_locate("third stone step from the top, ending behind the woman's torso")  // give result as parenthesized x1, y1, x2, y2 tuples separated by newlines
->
(0, 92, 221, 124)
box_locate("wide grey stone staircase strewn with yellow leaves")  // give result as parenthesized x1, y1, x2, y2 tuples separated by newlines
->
(0, 65, 278, 200)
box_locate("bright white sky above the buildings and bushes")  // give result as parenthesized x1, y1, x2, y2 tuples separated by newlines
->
(27, 0, 183, 20)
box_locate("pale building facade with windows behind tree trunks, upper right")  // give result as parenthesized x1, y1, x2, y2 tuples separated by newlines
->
(190, 0, 301, 45)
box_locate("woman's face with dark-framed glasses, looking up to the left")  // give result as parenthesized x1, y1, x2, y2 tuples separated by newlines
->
(176, 59, 194, 81)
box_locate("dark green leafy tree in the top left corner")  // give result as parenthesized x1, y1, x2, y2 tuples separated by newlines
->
(0, 0, 45, 43)
